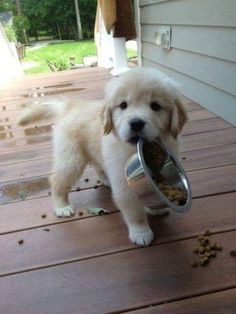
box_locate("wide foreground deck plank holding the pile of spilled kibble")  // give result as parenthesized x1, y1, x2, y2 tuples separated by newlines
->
(0, 231, 236, 314)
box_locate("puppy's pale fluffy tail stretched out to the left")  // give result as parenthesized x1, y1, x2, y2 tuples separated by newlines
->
(17, 101, 67, 125)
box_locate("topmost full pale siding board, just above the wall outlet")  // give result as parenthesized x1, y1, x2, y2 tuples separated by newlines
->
(141, 0, 236, 27)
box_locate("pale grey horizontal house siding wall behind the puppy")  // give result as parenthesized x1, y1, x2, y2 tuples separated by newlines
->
(139, 0, 236, 125)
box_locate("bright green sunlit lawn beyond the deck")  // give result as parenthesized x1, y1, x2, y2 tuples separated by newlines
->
(25, 40, 136, 74)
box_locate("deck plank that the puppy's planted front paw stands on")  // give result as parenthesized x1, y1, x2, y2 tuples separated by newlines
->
(0, 191, 236, 276)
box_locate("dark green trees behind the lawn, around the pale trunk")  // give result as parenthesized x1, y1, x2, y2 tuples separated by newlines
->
(22, 0, 97, 39)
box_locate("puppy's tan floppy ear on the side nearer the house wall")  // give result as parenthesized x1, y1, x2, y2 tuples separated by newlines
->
(170, 98, 188, 138)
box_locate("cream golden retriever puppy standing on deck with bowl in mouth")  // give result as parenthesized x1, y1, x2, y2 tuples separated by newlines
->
(19, 68, 187, 245)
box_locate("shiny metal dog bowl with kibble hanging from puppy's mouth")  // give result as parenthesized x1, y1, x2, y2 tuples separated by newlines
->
(126, 139, 192, 212)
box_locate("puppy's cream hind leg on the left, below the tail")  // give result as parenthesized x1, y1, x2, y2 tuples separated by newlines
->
(51, 141, 86, 217)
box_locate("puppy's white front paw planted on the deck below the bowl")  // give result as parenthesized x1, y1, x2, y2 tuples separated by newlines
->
(129, 226, 154, 246)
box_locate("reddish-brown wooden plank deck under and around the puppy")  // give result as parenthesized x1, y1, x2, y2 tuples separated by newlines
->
(0, 68, 236, 314)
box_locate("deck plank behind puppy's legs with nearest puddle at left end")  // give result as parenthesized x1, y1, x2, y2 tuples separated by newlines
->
(0, 156, 236, 204)
